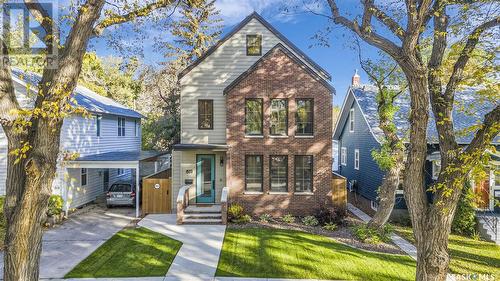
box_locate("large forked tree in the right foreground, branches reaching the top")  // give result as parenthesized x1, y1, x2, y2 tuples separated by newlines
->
(325, 0, 500, 280)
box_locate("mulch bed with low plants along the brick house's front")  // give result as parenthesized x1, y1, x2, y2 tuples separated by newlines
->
(228, 212, 406, 255)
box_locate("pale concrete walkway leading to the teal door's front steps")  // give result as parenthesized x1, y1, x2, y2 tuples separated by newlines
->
(141, 214, 226, 281)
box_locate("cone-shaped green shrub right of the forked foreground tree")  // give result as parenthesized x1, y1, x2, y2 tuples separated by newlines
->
(451, 181, 476, 237)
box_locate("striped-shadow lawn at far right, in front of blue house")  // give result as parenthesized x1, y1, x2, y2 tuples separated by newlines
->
(395, 226, 500, 276)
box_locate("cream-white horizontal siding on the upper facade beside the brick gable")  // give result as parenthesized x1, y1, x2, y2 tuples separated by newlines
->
(181, 19, 320, 144)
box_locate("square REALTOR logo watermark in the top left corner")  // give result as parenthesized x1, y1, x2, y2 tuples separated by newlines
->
(0, 0, 58, 68)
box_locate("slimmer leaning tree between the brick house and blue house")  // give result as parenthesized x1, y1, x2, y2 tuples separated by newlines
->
(358, 50, 406, 231)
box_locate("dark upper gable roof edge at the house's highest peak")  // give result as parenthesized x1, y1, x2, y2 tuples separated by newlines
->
(179, 12, 332, 80)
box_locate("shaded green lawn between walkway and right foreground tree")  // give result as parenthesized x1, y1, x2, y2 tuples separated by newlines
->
(216, 228, 415, 280)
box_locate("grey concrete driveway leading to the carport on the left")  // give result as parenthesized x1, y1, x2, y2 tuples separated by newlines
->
(0, 205, 134, 278)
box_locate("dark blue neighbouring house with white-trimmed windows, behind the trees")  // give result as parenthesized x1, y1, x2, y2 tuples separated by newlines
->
(333, 72, 500, 215)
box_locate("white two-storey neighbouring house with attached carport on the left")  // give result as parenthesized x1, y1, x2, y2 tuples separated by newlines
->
(0, 69, 169, 217)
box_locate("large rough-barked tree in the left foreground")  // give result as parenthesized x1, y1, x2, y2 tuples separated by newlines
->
(0, 0, 199, 281)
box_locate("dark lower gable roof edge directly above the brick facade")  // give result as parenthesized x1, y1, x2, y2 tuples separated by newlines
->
(223, 43, 335, 95)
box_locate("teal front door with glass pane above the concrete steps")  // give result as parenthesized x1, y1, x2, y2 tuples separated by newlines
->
(196, 154, 215, 203)
